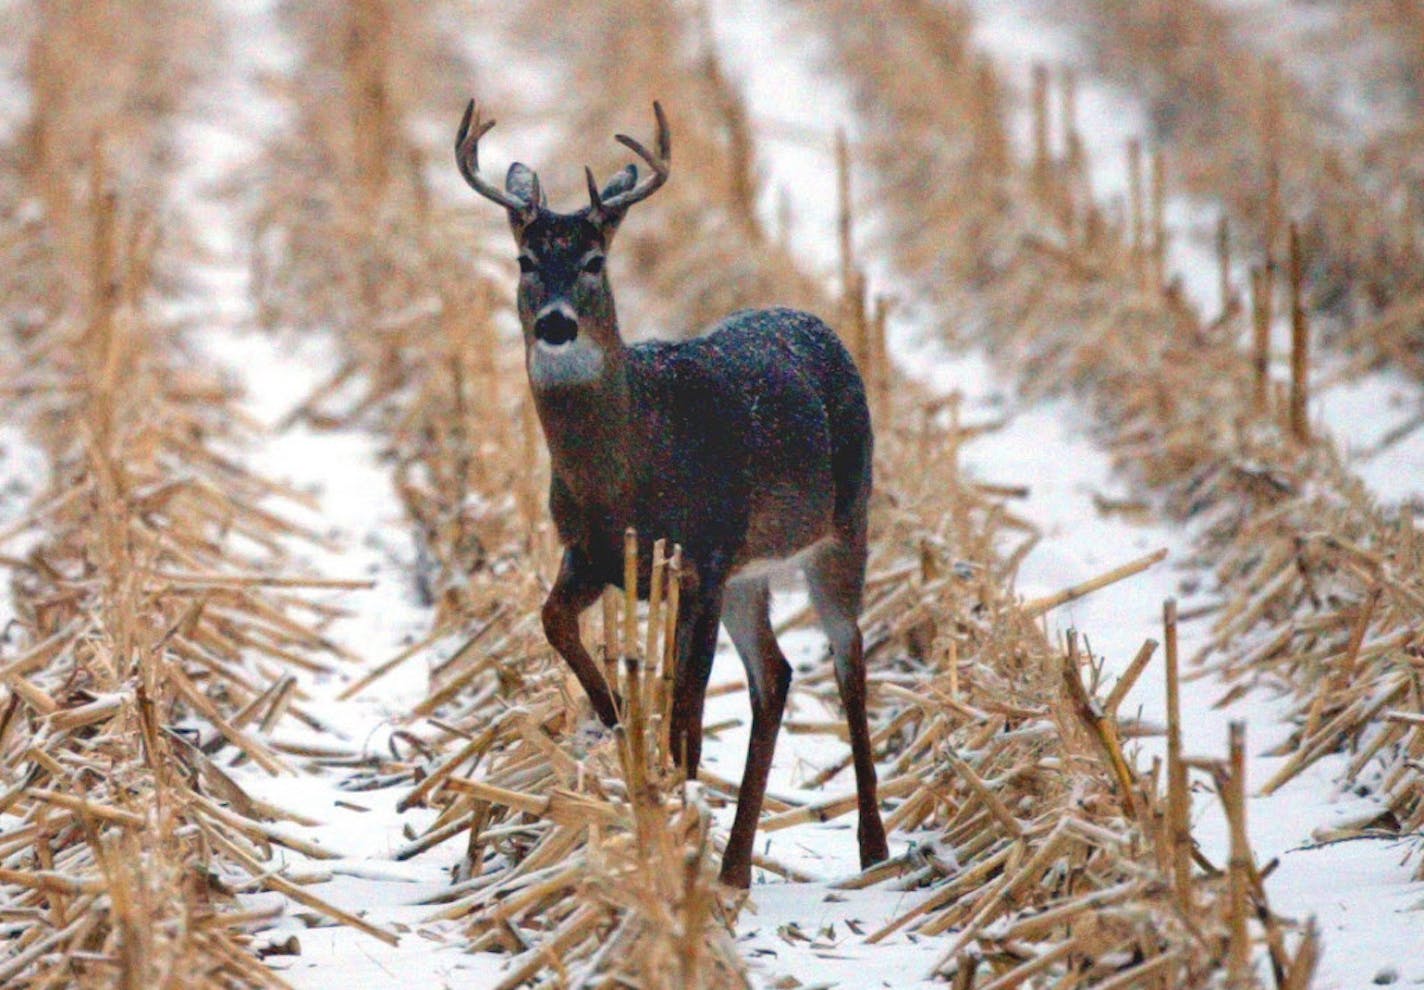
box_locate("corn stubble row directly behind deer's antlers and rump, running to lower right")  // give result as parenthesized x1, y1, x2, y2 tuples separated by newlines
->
(458, 3, 1310, 979)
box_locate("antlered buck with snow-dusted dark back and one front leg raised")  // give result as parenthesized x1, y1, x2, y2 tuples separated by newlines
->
(456, 100, 889, 889)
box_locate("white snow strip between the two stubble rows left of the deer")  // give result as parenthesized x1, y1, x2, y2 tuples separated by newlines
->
(163, 0, 489, 990)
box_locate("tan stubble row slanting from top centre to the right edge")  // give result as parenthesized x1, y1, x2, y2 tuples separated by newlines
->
(816, 4, 1417, 985)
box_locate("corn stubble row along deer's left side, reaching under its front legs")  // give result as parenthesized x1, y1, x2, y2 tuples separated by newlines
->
(247, 3, 743, 986)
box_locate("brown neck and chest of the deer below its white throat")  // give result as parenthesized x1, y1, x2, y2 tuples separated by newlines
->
(530, 340, 641, 513)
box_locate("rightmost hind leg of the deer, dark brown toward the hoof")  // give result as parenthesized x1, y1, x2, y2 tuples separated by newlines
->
(806, 538, 890, 869)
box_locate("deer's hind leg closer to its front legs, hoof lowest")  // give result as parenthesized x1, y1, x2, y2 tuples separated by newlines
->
(722, 578, 792, 887)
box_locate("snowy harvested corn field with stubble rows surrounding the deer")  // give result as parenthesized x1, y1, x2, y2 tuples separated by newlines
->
(0, 0, 1424, 990)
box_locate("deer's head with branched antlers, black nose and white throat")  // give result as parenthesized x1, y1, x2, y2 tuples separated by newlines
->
(456, 100, 672, 392)
